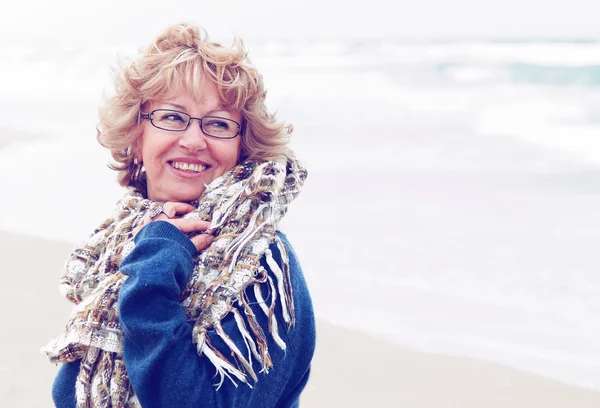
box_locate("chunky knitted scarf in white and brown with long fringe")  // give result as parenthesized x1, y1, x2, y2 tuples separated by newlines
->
(43, 154, 307, 407)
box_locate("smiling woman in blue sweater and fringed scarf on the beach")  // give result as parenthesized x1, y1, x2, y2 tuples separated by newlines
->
(44, 25, 315, 407)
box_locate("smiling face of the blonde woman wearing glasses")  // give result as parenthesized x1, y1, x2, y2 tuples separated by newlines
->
(138, 81, 242, 201)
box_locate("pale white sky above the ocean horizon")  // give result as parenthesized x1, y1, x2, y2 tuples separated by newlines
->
(0, 0, 600, 42)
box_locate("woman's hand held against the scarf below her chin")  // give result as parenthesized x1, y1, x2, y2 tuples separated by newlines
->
(133, 201, 215, 251)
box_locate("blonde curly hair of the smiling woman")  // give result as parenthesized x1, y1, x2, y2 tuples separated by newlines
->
(97, 24, 293, 190)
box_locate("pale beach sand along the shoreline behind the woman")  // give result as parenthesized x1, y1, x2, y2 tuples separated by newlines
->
(0, 232, 600, 408)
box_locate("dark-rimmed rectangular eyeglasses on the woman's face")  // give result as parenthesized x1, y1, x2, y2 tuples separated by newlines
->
(140, 109, 242, 139)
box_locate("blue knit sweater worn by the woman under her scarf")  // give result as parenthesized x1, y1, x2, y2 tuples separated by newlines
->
(52, 221, 315, 408)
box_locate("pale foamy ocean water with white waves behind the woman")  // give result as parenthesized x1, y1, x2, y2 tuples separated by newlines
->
(0, 39, 600, 390)
